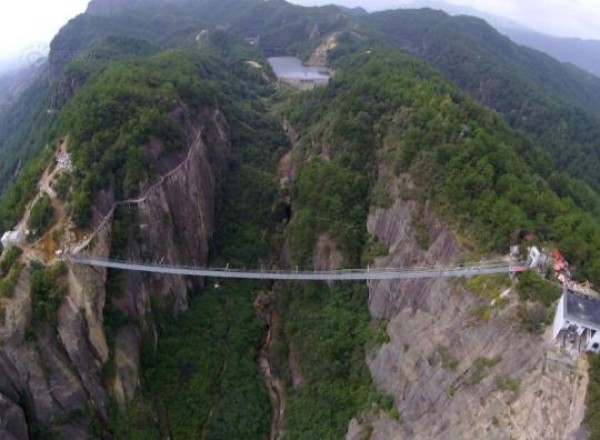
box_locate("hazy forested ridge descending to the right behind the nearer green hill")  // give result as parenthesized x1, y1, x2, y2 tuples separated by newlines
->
(368, 10, 600, 190)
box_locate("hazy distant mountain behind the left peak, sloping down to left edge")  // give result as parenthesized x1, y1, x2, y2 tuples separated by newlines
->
(0, 0, 356, 196)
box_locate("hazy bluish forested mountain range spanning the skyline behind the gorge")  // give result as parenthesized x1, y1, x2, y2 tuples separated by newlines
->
(0, 0, 600, 196)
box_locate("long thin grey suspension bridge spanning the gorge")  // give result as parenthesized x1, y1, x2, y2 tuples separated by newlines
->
(68, 255, 526, 281)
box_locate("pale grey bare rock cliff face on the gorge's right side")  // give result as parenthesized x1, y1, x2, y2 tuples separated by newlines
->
(347, 177, 587, 440)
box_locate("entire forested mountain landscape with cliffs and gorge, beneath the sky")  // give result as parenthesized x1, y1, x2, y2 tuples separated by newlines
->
(0, 0, 600, 439)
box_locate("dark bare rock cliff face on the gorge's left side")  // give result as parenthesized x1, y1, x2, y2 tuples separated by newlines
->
(0, 110, 230, 439)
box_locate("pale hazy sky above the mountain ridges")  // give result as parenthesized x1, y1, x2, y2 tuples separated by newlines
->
(0, 0, 600, 64)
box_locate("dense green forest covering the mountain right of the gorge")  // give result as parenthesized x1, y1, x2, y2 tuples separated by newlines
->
(289, 50, 600, 282)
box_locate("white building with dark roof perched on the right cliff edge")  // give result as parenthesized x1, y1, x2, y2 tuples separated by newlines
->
(552, 289, 600, 353)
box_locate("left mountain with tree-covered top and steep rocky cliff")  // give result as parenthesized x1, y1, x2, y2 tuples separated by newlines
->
(0, 33, 285, 437)
